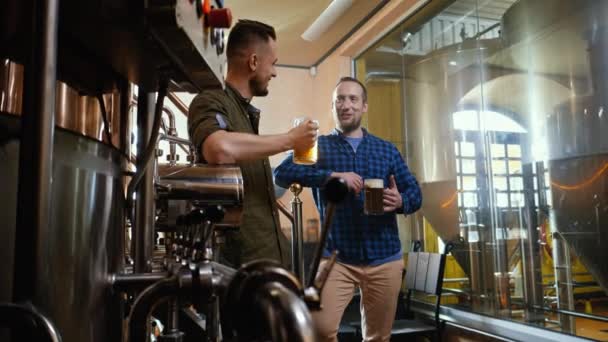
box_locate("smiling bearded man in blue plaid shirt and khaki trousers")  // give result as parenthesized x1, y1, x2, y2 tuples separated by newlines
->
(275, 77, 422, 341)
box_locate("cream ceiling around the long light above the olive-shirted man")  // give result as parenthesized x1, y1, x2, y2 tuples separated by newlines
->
(226, 0, 387, 67)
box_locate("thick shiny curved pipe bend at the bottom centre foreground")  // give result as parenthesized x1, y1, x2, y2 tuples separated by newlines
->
(254, 282, 316, 342)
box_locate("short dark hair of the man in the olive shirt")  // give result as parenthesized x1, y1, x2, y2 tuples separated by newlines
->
(226, 19, 277, 59)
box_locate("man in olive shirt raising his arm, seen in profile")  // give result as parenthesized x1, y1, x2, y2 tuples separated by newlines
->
(188, 20, 318, 267)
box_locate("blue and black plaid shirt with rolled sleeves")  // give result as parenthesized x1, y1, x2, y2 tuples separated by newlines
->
(274, 129, 422, 265)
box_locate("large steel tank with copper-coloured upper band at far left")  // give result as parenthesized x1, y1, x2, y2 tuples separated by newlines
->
(0, 61, 128, 342)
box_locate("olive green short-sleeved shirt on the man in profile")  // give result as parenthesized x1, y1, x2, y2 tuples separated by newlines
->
(188, 84, 290, 267)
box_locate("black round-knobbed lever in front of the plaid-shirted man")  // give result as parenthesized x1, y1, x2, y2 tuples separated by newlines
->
(308, 178, 348, 287)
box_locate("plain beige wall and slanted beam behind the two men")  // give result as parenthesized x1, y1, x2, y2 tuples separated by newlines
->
(247, 0, 426, 235)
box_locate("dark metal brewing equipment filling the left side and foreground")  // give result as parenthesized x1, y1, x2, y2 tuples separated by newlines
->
(0, 0, 328, 342)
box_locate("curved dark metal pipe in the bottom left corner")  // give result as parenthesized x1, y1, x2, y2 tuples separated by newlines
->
(0, 303, 62, 342)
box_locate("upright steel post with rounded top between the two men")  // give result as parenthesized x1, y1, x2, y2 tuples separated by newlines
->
(289, 183, 305, 284)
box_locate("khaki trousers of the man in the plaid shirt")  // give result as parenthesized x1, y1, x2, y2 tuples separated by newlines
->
(312, 259, 404, 341)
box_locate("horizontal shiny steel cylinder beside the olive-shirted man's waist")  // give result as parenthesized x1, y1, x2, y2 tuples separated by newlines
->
(156, 164, 245, 227)
